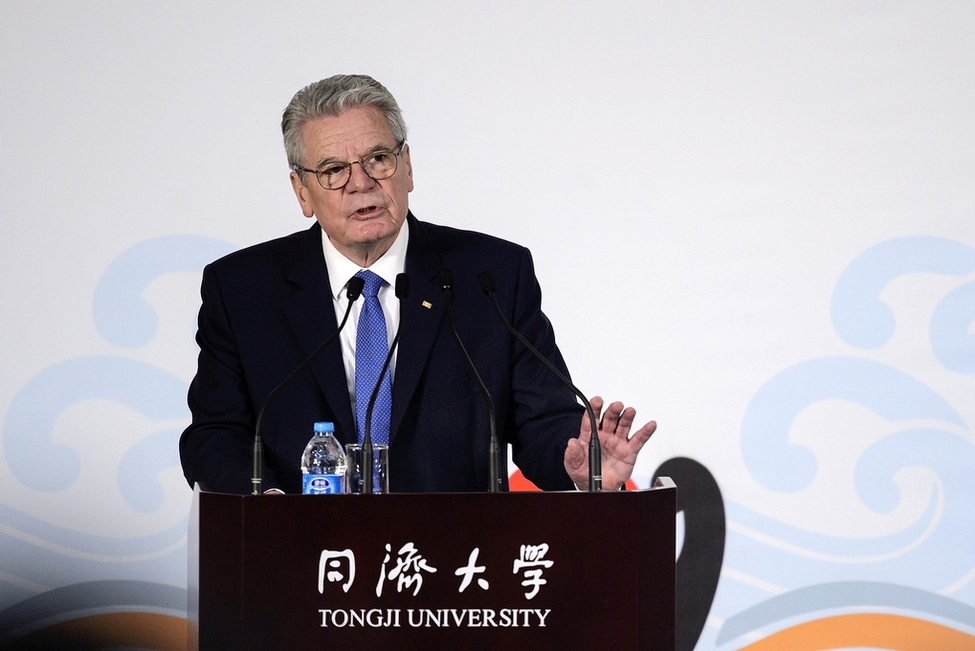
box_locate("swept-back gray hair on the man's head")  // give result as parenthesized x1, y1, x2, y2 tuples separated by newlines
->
(281, 75, 406, 172)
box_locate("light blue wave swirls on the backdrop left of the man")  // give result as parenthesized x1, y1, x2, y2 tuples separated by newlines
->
(0, 235, 233, 639)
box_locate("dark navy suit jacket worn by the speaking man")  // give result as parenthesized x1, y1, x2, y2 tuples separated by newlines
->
(180, 214, 582, 494)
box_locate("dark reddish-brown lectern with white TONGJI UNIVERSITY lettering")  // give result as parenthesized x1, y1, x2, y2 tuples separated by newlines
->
(188, 478, 677, 651)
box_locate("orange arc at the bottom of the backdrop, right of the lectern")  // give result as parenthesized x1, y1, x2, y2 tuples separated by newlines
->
(739, 613, 975, 651)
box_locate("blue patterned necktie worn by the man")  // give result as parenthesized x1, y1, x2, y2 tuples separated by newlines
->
(355, 270, 393, 445)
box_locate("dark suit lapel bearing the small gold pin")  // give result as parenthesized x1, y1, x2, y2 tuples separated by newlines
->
(390, 213, 445, 437)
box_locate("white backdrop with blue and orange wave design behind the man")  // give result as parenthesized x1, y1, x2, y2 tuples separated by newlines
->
(0, 0, 975, 649)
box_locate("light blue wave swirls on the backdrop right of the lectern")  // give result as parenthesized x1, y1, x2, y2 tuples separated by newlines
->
(698, 237, 975, 648)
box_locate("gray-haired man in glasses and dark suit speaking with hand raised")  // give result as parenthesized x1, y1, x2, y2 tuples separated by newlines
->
(180, 75, 656, 493)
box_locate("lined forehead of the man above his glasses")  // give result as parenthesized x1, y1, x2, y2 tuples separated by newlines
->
(302, 106, 397, 160)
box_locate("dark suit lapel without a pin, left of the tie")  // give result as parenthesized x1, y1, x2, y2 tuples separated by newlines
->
(284, 224, 356, 441)
